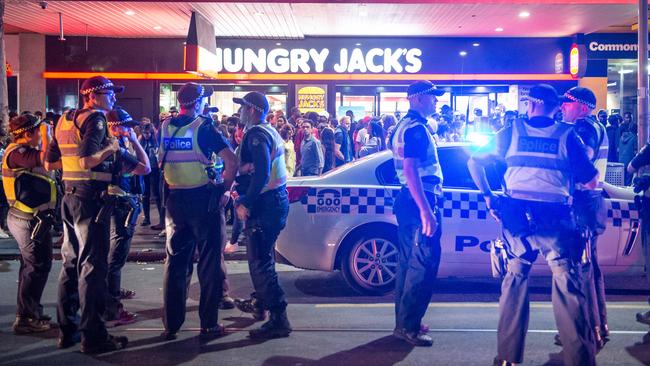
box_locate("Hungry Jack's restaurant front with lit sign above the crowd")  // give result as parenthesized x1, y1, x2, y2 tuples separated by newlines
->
(45, 37, 577, 120)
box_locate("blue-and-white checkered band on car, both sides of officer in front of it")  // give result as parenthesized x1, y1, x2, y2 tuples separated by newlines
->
(301, 187, 487, 220)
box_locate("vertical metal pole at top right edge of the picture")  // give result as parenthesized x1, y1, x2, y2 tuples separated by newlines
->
(637, 0, 648, 149)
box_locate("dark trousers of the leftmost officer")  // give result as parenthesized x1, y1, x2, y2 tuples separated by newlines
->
(7, 213, 52, 319)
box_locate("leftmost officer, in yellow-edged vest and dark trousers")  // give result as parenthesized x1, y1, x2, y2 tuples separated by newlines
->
(2, 114, 57, 334)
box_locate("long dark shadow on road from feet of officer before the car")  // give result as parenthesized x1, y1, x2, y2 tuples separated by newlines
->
(262, 336, 413, 366)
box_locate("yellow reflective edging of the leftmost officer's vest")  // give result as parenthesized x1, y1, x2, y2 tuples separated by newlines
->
(2, 143, 57, 214)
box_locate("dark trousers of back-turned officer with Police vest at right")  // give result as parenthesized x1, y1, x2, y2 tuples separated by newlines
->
(497, 199, 595, 365)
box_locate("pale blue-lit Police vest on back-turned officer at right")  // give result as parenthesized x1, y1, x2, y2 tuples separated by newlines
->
(505, 120, 573, 203)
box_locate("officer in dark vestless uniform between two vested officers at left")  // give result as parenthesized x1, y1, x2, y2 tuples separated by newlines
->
(106, 107, 151, 325)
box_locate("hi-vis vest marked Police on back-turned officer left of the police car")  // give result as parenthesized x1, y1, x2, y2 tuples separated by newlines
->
(158, 116, 212, 189)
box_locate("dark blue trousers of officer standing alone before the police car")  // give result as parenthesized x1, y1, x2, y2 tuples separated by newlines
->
(393, 188, 442, 333)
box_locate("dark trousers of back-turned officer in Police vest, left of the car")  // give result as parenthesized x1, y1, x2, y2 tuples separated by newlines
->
(163, 187, 223, 332)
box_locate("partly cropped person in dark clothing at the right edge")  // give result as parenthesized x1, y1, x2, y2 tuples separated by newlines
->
(627, 144, 650, 325)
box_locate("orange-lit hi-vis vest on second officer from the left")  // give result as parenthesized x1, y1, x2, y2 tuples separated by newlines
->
(54, 109, 111, 182)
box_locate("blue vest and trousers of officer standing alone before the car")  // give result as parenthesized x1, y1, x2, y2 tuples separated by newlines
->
(389, 110, 443, 334)
